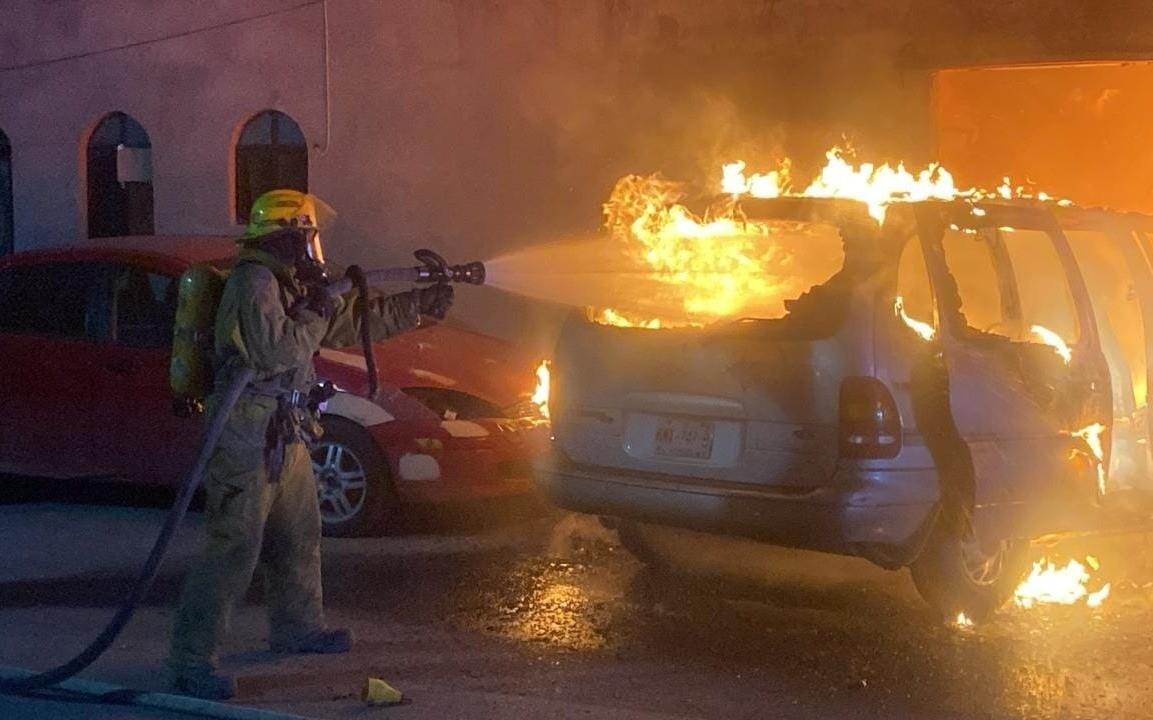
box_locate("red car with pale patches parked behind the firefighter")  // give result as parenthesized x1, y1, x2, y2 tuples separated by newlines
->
(0, 237, 548, 535)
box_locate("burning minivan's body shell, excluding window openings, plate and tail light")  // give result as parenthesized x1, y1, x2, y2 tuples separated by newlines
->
(537, 197, 1153, 617)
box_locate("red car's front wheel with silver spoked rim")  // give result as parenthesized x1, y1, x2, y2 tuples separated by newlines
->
(312, 415, 400, 538)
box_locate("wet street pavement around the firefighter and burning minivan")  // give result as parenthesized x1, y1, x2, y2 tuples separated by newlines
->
(0, 480, 1153, 720)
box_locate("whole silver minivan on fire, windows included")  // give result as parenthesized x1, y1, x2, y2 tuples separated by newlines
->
(537, 196, 1153, 620)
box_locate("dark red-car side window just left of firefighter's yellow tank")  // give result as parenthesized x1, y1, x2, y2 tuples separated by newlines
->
(112, 265, 178, 347)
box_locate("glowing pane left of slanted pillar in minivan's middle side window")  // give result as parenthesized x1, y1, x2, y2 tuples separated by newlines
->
(941, 230, 1010, 337)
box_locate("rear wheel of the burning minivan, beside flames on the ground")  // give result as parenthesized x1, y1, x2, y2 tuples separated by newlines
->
(910, 516, 1030, 622)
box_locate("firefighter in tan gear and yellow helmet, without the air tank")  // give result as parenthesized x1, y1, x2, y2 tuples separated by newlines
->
(168, 190, 453, 699)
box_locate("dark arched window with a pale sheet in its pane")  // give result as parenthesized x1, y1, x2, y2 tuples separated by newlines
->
(88, 112, 155, 238)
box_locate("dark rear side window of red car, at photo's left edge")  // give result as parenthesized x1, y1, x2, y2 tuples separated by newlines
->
(0, 262, 107, 339)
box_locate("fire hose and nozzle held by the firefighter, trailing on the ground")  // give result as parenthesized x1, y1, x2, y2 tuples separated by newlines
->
(0, 249, 484, 702)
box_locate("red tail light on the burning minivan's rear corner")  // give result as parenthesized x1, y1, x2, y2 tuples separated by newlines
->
(839, 377, 902, 459)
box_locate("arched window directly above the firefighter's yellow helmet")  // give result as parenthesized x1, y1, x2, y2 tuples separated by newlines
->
(235, 110, 308, 224)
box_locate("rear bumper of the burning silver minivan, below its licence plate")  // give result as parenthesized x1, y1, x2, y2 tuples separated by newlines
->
(536, 456, 939, 568)
